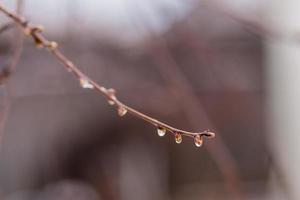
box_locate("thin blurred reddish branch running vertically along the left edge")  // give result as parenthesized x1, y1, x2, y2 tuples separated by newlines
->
(0, 0, 24, 145)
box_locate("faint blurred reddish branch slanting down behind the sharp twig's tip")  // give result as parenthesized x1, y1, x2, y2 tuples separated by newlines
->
(146, 33, 242, 199)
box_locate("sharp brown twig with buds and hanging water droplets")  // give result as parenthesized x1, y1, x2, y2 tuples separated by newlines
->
(0, 4, 215, 147)
